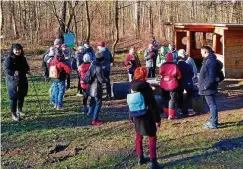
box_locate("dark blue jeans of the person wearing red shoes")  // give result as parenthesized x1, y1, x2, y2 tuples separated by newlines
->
(89, 97, 102, 120)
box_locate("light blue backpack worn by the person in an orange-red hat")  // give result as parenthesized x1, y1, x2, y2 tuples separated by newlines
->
(127, 92, 147, 117)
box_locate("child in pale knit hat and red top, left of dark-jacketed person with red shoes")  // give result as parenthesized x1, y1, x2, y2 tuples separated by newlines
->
(79, 54, 91, 115)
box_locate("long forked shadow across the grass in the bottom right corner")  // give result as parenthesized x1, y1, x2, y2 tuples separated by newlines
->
(159, 137, 243, 168)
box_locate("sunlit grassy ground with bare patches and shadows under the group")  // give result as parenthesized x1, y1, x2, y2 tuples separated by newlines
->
(1, 57, 243, 169)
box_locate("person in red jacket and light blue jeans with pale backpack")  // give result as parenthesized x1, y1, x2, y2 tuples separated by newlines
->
(49, 49, 72, 110)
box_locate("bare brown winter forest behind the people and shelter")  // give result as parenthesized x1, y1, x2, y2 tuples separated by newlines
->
(0, 0, 243, 47)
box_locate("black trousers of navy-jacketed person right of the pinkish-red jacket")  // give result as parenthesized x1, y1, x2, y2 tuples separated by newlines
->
(178, 89, 193, 114)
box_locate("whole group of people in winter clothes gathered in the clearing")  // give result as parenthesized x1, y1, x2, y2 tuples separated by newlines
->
(4, 39, 221, 169)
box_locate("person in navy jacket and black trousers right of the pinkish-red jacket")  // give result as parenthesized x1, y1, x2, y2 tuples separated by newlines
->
(177, 53, 194, 117)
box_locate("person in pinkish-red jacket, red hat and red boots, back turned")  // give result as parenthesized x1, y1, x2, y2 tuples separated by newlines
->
(159, 53, 181, 119)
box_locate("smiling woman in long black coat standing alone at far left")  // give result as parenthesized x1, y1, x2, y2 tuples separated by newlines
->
(4, 44, 30, 121)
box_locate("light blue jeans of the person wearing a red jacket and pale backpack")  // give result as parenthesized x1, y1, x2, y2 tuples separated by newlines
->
(51, 80, 65, 107)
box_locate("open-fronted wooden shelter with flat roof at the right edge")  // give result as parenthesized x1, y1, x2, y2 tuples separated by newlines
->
(173, 23, 243, 78)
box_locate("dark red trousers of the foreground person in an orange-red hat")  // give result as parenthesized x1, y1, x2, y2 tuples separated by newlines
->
(136, 133, 157, 159)
